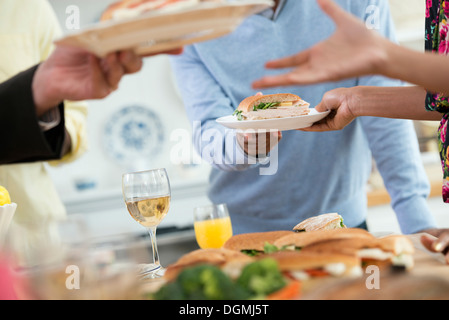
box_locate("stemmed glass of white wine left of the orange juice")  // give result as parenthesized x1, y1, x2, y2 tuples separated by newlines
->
(122, 169, 171, 279)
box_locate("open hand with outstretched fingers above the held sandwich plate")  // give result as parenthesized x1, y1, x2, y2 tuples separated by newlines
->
(253, 0, 391, 89)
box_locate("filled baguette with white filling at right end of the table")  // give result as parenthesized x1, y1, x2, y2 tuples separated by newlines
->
(302, 235, 415, 270)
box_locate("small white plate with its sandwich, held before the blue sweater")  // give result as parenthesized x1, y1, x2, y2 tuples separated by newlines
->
(217, 93, 330, 131)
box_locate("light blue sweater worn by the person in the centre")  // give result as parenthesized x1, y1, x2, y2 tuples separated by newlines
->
(172, 0, 436, 234)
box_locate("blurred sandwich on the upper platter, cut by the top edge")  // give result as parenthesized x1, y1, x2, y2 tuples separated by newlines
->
(100, 0, 223, 21)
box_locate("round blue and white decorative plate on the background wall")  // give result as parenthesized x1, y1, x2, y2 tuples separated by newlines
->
(104, 105, 164, 170)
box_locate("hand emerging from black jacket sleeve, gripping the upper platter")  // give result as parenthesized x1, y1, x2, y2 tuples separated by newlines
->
(32, 46, 182, 116)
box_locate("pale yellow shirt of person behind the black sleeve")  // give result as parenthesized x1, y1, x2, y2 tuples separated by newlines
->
(0, 0, 87, 224)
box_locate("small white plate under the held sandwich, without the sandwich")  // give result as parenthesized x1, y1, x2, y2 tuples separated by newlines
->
(217, 108, 330, 131)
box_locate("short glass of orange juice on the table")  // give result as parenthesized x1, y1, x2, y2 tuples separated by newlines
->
(193, 204, 232, 249)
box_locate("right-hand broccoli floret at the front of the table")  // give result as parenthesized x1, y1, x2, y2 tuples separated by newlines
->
(237, 258, 286, 296)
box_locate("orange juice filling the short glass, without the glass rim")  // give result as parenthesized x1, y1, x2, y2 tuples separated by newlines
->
(194, 217, 232, 249)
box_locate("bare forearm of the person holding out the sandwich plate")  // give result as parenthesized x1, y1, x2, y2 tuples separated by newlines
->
(348, 86, 442, 121)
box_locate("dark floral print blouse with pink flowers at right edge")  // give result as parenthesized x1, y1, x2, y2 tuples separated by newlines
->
(426, 0, 449, 203)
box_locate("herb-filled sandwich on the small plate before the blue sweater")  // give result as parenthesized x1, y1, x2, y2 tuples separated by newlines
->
(234, 93, 310, 121)
